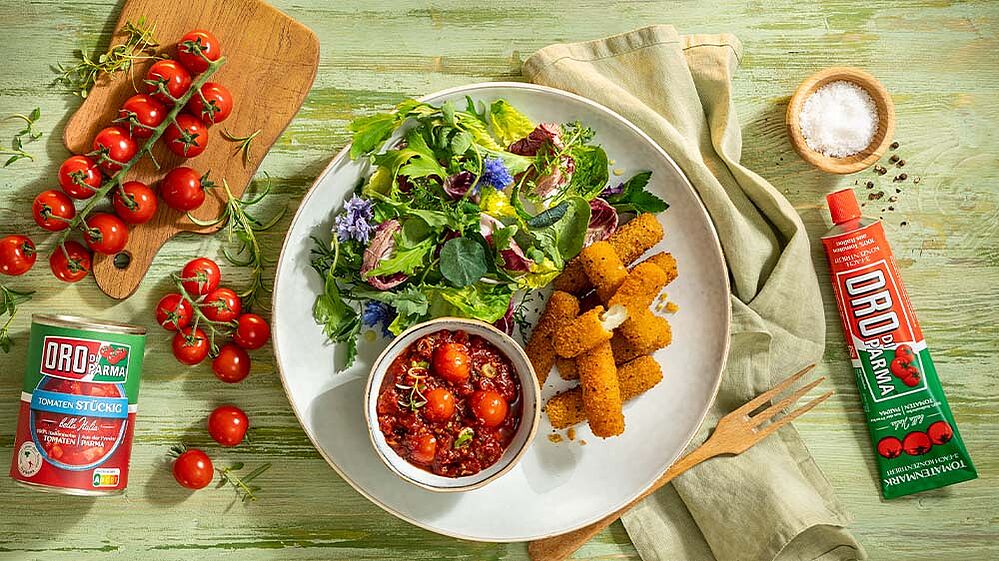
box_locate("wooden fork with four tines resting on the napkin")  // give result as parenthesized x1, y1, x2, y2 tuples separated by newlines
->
(527, 364, 834, 561)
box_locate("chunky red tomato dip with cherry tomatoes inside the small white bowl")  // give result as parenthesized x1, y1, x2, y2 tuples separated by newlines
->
(376, 330, 523, 477)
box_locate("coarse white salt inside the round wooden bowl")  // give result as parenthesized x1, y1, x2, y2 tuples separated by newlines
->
(798, 80, 878, 158)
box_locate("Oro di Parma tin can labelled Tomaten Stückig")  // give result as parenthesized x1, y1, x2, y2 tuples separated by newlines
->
(10, 314, 146, 496)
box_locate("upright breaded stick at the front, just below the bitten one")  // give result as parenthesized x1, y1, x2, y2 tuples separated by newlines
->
(576, 341, 624, 438)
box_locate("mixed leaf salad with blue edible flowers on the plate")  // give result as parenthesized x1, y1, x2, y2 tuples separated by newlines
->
(312, 98, 668, 366)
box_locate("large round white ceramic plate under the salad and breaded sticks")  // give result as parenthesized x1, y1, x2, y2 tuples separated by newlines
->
(272, 83, 730, 542)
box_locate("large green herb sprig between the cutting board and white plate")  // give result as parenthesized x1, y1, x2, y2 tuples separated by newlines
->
(187, 177, 286, 309)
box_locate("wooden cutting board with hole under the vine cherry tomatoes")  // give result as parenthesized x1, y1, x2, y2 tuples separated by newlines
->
(63, 0, 319, 299)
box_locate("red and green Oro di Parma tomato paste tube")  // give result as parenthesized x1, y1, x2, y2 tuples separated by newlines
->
(822, 189, 978, 499)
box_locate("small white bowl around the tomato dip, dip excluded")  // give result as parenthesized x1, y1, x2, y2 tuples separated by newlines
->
(364, 317, 541, 492)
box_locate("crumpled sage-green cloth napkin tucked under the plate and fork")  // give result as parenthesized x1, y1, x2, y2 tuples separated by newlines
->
(524, 25, 866, 561)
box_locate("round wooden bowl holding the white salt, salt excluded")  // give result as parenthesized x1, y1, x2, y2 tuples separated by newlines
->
(785, 66, 895, 174)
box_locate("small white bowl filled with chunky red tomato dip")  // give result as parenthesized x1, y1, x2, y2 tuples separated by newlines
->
(364, 318, 541, 492)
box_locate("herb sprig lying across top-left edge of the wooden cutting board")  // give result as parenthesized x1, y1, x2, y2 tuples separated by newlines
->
(53, 17, 166, 98)
